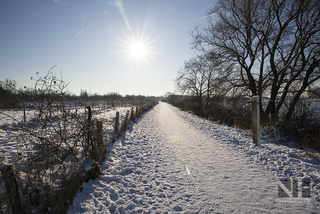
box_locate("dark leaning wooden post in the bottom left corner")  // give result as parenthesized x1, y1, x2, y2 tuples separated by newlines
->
(1, 165, 31, 214)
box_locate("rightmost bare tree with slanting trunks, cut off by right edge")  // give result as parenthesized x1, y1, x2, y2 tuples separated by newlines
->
(259, 0, 320, 120)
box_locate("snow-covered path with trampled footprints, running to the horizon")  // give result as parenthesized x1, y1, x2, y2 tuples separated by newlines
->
(68, 103, 320, 214)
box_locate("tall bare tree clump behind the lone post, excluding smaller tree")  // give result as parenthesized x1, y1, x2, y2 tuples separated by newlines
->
(192, 0, 320, 122)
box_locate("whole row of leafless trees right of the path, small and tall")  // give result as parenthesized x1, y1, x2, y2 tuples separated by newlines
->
(176, 0, 320, 124)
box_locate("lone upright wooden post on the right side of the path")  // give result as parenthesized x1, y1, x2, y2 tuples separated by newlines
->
(252, 96, 260, 146)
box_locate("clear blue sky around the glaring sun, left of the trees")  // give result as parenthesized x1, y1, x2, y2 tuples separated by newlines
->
(0, 0, 213, 96)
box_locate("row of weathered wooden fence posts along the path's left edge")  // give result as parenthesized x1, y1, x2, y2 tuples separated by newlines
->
(0, 102, 156, 214)
